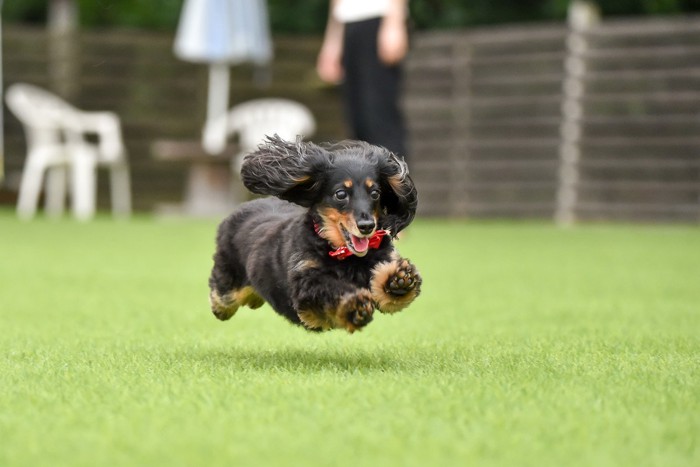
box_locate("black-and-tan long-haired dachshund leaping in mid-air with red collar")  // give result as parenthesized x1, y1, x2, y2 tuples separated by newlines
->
(209, 136, 421, 332)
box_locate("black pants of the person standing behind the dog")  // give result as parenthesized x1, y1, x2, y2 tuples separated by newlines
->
(343, 18, 406, 157)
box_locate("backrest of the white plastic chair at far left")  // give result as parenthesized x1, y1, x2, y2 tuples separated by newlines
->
(5, 83, 78, 145)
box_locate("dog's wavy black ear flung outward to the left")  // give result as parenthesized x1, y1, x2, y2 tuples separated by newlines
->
(241, 135, 329, 207)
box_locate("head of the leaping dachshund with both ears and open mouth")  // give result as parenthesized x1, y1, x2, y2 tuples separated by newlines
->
(241, 136, 418, 256)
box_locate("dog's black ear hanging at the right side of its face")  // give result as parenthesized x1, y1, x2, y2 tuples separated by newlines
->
(379, 148, 418, 236)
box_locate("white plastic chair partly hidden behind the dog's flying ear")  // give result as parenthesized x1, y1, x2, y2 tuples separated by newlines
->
(203, 98, 316, 168)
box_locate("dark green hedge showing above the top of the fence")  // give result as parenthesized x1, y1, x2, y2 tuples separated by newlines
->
(3, 0, 700, 34)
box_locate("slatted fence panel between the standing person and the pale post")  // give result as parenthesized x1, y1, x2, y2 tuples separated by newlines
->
(406, 26, 566, 217)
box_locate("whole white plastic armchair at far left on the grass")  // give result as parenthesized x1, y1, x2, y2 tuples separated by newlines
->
(5, 83, 131, 220)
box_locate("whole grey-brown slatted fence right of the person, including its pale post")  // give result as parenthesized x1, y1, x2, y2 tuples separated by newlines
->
(406, 5, 700, 223)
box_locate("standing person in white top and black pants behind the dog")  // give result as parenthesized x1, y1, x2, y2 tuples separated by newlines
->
(316, 0, 408, 161)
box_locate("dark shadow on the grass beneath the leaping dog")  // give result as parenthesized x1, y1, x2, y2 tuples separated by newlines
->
(184, 347, 423, 373)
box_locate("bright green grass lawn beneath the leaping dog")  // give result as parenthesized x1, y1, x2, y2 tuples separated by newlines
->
(0, 210, 700, 467)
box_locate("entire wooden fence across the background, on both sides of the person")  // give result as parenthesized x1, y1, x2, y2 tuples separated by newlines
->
(4, 5, 700, 222)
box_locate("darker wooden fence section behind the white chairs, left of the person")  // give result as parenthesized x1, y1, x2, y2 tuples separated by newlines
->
(3, 27, 345, 211)
